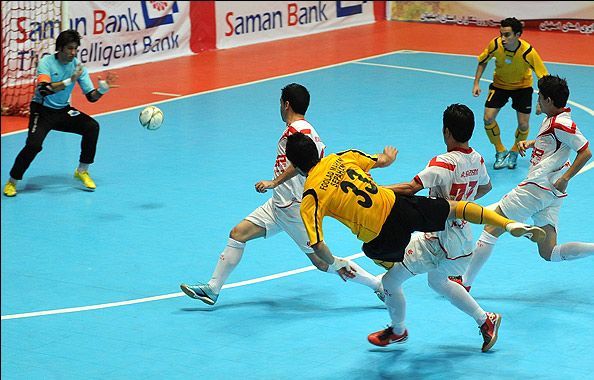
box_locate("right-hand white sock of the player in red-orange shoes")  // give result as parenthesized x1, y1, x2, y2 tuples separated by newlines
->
(427, 272, 487, 326)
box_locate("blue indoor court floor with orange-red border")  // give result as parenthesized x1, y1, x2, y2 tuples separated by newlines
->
(0, 22, 594, 379)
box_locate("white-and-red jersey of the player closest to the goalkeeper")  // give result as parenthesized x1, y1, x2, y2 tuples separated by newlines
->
(272, 119, 326, 208)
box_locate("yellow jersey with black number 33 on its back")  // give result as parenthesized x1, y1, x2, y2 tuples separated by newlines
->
(300, 150, 396, 246)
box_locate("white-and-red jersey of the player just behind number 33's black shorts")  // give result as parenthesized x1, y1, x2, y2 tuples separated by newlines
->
(415, 148, 491, 259)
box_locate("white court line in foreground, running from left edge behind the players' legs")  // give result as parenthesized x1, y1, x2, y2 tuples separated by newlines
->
(2, 252, 364, 321)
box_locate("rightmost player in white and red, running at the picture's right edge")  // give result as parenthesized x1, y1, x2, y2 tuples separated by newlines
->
(463, 75, 594, 288)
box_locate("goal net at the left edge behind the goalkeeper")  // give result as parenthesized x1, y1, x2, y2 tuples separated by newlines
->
(2, 1, 67, 116)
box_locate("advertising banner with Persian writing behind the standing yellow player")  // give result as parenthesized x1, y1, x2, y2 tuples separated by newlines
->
(388, 1, 594, 35)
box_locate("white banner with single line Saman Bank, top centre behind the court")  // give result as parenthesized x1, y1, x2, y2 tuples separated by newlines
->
(215, 1, 375, 49)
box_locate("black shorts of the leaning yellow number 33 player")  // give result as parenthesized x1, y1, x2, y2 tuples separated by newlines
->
(363, 195, 450, 262)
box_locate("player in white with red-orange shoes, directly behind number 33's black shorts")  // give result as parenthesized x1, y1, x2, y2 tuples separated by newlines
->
(368, 104, 501, 351)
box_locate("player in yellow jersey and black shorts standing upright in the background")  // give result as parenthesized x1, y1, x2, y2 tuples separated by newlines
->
(472, 17, 548, 170)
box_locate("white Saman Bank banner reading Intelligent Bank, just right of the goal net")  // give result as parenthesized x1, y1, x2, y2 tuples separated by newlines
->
(68, 1, 192, 72)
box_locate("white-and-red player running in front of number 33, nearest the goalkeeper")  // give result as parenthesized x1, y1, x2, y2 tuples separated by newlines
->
(180, 83, 383, 305)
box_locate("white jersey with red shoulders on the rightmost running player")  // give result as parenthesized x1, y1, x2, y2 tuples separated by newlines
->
(518, 108, 589, 198)
